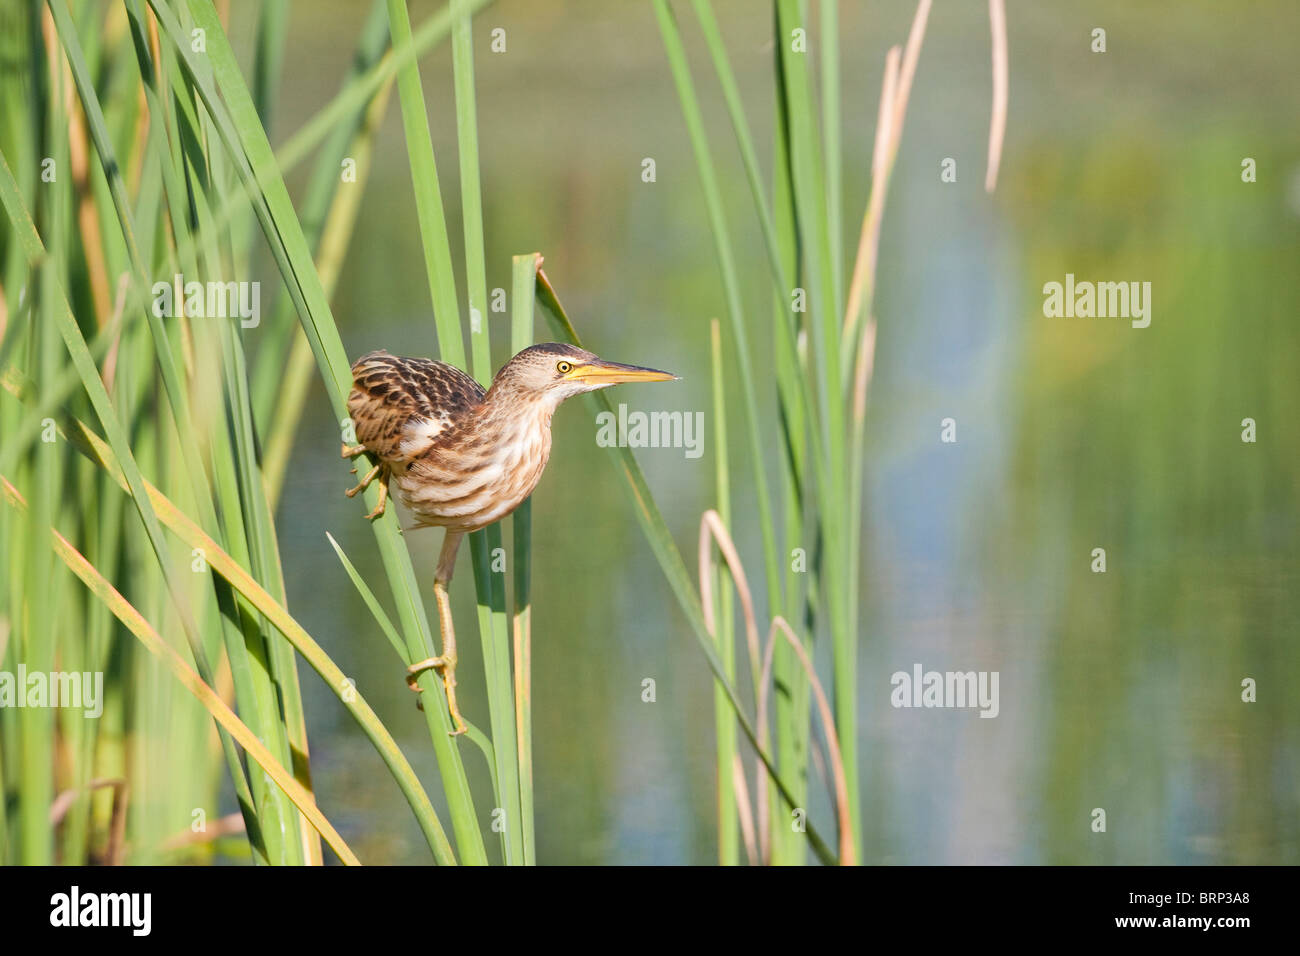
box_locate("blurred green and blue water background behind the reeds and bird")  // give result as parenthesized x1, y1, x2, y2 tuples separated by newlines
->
(244, 0, 1300, 864)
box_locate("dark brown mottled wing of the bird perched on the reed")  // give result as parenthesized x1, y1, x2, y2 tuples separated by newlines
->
(347, 351, 485, 463)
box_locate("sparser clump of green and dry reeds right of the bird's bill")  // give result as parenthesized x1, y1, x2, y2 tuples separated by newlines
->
(629, 0, 1008, 865)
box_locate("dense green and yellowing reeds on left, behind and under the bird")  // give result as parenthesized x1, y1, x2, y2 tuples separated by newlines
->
(0, 0, 532, 864)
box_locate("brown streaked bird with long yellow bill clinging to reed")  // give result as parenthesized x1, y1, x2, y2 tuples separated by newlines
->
(343, 342, 677, 735)
